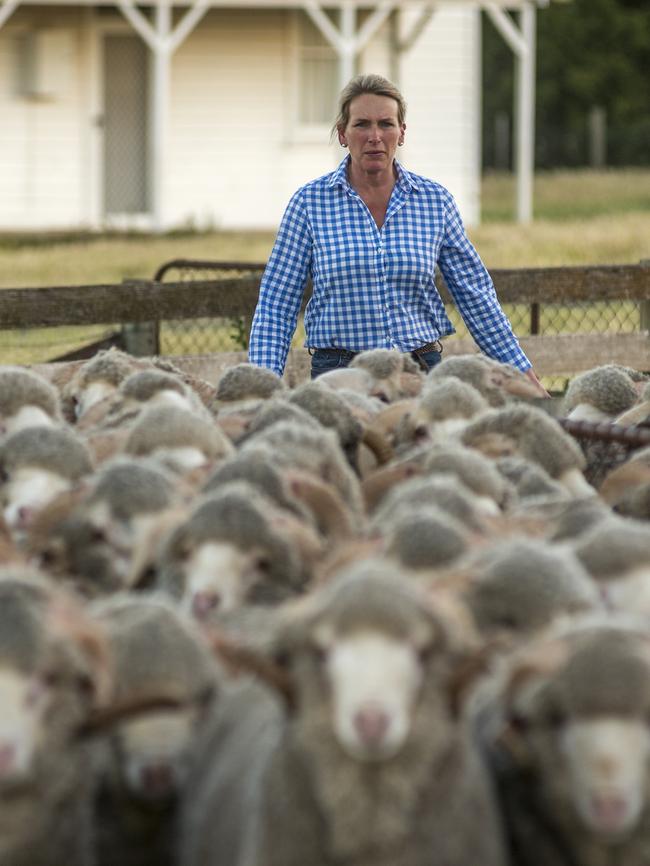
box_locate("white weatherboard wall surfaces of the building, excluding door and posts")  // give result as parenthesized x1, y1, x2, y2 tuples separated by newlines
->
(0, 1, 480, 230)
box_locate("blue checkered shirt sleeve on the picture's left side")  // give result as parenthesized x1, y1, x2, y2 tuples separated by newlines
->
(248, 190, 312, 375)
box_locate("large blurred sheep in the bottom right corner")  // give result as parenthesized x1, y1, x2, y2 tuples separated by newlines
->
(476, 619, 650, 866)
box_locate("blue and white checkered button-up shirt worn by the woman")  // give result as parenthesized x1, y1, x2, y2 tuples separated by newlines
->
(248, 156, 531, 374)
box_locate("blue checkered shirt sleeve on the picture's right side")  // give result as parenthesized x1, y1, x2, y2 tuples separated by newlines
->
(438, 195, 532, 370)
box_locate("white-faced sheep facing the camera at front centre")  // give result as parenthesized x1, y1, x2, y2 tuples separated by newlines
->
(181, 561, 505, 866)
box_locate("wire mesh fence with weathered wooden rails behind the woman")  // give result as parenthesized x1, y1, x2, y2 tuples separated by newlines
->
(0, 259, 650, 394)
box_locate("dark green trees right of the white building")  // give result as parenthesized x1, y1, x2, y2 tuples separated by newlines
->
(483, 0, 650, 168)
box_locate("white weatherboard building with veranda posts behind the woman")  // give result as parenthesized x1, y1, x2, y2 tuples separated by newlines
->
(0, 0, 539, 231)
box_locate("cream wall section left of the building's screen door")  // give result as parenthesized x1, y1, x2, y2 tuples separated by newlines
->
(0, 7, 91, 229)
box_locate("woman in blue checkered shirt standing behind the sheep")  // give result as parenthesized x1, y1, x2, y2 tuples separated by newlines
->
(249, 75, 546, 396)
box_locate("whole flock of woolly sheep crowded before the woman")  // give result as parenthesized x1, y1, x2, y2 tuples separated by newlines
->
(0, 350, 650, 866)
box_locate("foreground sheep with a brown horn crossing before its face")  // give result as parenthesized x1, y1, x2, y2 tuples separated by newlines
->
(92, 594, 220, 866)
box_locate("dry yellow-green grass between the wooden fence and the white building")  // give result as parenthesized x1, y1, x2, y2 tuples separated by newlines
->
(0, 168, 650, 363)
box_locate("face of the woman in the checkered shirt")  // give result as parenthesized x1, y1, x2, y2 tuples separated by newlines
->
(339, 93, 406, 174)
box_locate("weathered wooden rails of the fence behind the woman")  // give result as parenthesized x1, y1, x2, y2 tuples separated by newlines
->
(0, 261, 650, 376)
